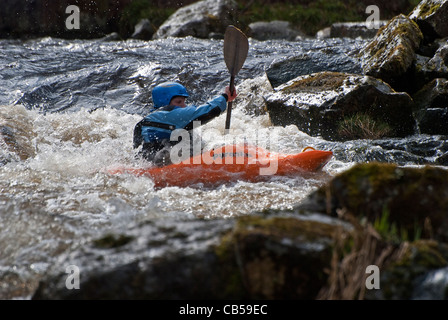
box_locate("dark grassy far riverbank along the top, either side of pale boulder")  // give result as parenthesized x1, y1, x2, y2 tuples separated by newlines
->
(0, 0, 419, 39)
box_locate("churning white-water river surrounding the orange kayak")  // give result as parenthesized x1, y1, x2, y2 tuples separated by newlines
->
(0, 37, 448, 299)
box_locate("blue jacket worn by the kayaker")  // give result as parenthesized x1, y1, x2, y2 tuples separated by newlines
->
(134, 94, 227, 151)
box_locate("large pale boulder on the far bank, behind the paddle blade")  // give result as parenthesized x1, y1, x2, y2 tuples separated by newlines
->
(153, 0, 237, 39)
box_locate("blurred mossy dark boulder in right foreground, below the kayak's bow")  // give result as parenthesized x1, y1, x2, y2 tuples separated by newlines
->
(295, 162, 448, 242)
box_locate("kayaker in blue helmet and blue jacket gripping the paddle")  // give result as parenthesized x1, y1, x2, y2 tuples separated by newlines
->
(133, 82, 237, 166)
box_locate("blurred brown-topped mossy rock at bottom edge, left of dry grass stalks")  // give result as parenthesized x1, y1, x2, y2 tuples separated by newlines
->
(234, 216, 340, 299)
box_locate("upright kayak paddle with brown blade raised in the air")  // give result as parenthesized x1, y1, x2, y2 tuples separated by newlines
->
(224, 26, 249, 131)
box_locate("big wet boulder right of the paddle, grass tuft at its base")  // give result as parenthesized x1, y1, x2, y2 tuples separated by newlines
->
(266, 72, 415, 141)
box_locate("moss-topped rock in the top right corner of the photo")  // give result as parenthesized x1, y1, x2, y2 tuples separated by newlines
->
(409, 0, 448, 42)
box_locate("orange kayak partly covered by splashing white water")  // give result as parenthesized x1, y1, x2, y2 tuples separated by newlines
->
(107, 145, 333, 188)
